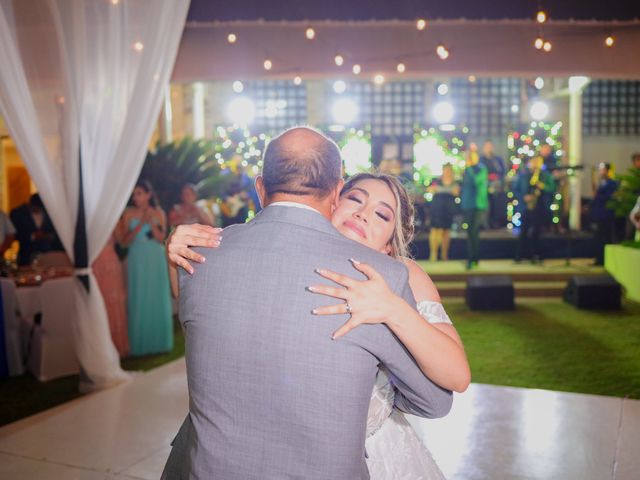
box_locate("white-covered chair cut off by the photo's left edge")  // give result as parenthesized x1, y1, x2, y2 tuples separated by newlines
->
(0, 278, 25, 376)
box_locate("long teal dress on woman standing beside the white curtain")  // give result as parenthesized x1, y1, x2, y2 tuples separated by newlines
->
(127, 218, 173, 355)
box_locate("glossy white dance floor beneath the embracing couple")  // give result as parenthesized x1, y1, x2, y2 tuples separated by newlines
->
(0, 360, 640, 480)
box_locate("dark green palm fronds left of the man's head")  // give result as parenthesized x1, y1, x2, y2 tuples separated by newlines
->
(140, 137, 235, 211)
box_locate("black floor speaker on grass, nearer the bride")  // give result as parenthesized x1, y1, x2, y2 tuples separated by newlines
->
(466, 275, 515, 310)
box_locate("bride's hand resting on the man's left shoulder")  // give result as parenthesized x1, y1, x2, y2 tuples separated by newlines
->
(166, 223, 222, 273)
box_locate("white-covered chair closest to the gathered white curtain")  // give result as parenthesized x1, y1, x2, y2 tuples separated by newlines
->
(28, 278, 80, 382)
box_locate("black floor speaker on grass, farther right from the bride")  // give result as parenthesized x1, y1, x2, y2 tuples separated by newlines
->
(564, 275, 622, 310)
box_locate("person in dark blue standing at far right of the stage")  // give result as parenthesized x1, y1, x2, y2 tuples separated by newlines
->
(591, 163, 618, 265)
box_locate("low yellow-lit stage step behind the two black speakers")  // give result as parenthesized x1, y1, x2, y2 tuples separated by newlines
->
(417, 258, 606, 298)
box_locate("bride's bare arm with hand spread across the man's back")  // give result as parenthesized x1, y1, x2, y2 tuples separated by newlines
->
(309, 261, 471, 392)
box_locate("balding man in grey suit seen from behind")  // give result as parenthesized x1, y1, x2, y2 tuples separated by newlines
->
(163, 128, 452, 480)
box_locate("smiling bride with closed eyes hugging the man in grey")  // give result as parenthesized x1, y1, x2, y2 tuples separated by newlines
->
(167, 173, 470, 480)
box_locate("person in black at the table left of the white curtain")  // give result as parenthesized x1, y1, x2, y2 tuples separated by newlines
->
(11, 193, 64, 265)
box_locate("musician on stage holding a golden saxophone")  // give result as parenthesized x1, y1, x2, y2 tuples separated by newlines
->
(513, 156, 556, 263)
